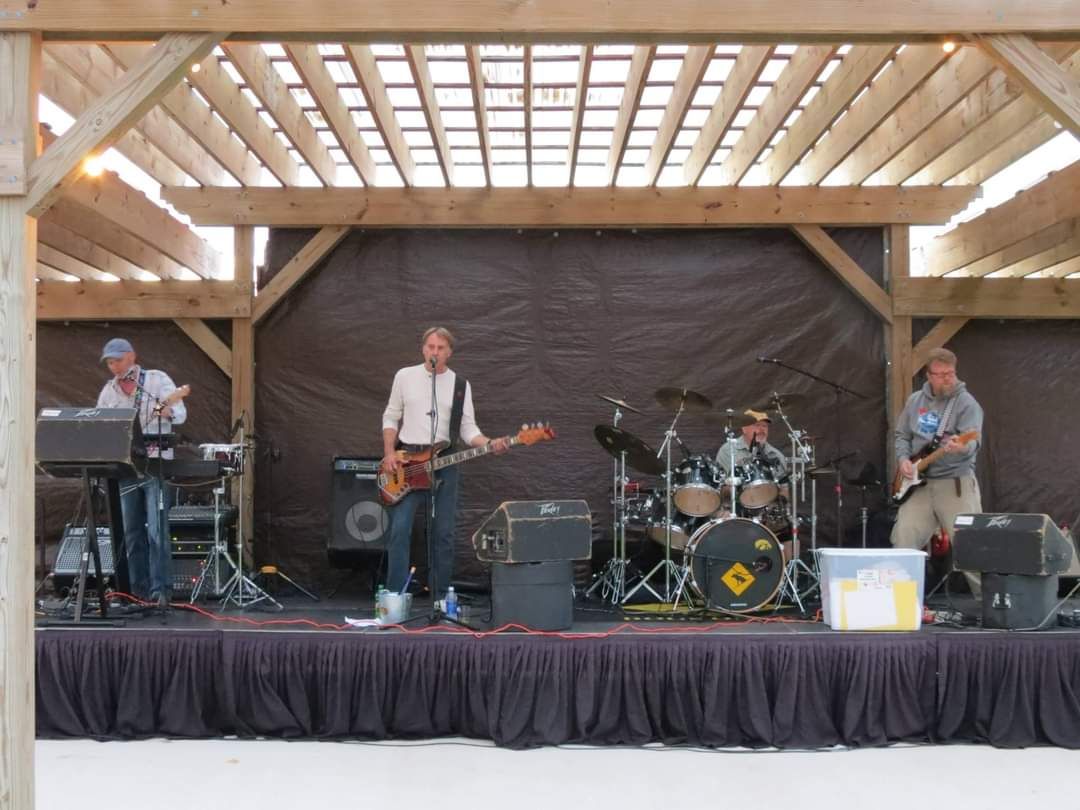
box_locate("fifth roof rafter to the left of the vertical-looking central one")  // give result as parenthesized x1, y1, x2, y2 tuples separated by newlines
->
(225, 43, 337, 186)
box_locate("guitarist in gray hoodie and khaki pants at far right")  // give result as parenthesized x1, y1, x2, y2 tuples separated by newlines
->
(891, 349, 983, 596)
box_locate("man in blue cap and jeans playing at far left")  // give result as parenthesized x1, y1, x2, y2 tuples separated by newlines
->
(97, 338, 188, 608)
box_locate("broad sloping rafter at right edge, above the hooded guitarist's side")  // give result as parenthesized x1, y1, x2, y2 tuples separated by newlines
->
(926, 161, 1080, 275)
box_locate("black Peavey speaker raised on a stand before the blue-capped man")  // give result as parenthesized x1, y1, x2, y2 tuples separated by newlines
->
(36, 408, 146, 478)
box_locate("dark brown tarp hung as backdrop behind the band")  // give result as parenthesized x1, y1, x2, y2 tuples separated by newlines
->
(38, 229, 1080, 588)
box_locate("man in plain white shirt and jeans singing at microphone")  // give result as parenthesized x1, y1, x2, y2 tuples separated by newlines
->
(382, 326, 509, 599)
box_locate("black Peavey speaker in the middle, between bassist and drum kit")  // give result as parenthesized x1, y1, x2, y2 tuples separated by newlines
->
(472, 501, 593, 563)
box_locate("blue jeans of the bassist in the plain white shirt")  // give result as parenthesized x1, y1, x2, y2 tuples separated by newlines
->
(387, 467, 459, 599)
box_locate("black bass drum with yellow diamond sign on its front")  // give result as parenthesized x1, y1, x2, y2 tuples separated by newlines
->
(684, 517, 784, 613)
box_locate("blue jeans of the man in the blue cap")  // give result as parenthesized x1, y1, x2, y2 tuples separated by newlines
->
(120, 477, 173, 599)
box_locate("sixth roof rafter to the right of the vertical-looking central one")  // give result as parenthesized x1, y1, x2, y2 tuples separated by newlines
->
(761, 44, 900, 185)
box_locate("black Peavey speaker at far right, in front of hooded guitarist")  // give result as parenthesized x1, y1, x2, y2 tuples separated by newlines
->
(953, 513, 1072, 576)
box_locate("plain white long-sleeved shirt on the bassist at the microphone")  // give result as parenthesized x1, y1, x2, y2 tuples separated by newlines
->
(382, 364, 482, 445)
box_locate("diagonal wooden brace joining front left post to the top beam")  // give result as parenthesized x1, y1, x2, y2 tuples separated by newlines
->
(26, 33, 220, 217)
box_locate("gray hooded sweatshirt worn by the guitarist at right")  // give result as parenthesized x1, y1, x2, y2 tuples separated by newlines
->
(893, 380, 983, 478)
